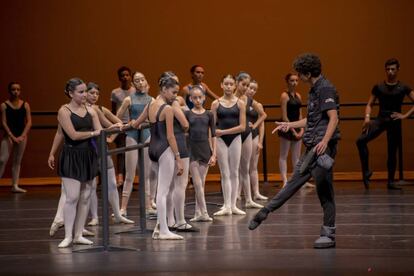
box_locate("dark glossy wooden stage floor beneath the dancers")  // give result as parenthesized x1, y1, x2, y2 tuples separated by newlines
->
(0, 182, 414, 275)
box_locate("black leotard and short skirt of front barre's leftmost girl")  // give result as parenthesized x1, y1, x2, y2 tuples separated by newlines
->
(58, 106, 98, 182)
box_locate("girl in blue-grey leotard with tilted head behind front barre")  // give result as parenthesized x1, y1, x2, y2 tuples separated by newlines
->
(116, 72, 156, 216)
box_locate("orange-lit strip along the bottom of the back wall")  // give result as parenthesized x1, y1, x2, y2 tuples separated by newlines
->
(0, 171, 414, 186)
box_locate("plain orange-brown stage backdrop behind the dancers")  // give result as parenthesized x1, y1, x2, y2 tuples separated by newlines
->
(0, 0, 414, 177)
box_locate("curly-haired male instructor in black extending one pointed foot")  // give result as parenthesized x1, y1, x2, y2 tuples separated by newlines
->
(249, 54, 340, 248)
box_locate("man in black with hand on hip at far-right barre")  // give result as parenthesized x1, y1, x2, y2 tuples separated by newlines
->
(357, 58, 414, 190)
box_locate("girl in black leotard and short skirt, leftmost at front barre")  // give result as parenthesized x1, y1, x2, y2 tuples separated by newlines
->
(58, 78, 102, 247)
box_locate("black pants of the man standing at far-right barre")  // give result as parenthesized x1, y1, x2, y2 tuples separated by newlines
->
(356, 117, 401, 183)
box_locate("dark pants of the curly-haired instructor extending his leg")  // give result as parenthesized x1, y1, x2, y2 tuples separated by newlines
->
(266, 141, 337, 227)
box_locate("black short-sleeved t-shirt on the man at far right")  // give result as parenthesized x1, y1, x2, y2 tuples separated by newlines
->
(372, 82, 412, 117)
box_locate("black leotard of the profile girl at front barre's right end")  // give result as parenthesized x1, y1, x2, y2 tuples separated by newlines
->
(148, 104, 170, 162)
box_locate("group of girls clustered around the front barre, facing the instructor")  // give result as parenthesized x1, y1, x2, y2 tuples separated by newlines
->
(44, 69, 267, 247)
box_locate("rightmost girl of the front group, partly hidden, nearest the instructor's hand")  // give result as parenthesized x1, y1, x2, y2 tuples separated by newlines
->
(246, 80, 268, 200)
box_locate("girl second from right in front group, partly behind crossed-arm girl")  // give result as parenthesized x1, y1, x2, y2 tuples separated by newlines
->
(234, 72, 266, 208)
